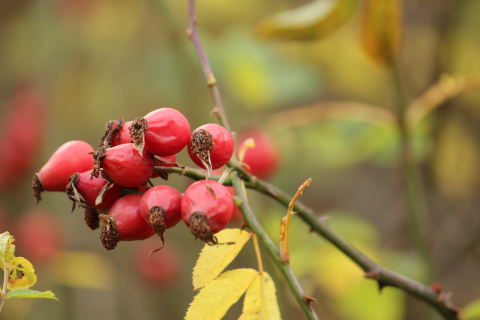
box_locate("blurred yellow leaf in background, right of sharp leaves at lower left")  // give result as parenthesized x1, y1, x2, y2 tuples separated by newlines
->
(55, 251, 115, 290)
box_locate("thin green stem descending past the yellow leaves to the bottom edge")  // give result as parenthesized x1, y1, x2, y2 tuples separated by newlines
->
(232, 172, 318, 319)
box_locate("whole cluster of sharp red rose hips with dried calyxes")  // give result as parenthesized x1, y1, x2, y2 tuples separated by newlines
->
(31, 108, 238, 250)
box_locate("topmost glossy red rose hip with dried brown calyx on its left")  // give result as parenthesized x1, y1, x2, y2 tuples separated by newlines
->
(130, 108, 190, 157)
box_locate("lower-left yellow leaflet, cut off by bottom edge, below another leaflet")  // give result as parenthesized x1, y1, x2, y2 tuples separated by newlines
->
(185, 269, 258, 320)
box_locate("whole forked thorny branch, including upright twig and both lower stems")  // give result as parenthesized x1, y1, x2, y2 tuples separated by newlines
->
(184, 0, 460, 320)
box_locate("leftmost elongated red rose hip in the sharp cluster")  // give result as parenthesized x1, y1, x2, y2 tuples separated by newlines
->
(31, 141, 94, 203)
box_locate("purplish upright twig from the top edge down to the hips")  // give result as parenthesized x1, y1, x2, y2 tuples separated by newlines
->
(187, 0, 231, 132)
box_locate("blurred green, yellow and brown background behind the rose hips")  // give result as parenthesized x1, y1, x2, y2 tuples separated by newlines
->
(0, 0, 480, 320)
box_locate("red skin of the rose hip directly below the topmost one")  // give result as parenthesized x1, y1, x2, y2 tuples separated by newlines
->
(102, 143, 154, 187)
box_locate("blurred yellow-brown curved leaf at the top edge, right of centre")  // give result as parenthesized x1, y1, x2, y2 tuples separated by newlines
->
(256, 0, 357, 40)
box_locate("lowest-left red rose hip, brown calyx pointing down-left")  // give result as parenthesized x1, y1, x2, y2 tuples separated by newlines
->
(100, 194, 155, 250)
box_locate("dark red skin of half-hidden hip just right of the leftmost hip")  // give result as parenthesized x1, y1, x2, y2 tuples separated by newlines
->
(75, 170, 122, 210)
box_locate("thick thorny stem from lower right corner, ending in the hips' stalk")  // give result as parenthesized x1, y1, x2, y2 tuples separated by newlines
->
(155, 166, 459, 320)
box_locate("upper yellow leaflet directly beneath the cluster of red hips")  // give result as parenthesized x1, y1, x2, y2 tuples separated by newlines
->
(193, 229, 252, 289)
